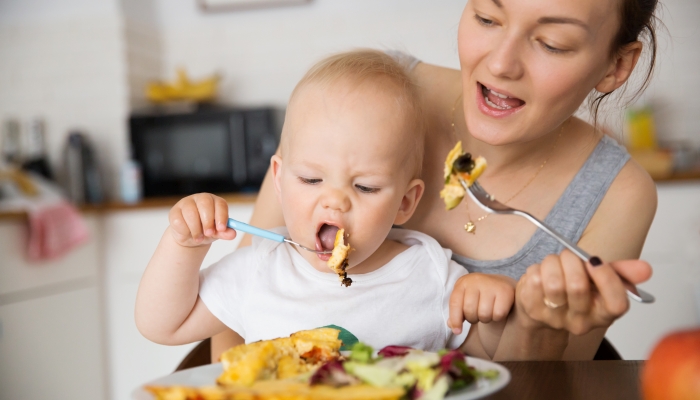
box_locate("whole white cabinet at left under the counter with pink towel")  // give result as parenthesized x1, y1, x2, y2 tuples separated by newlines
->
(0, 214, 107, 400)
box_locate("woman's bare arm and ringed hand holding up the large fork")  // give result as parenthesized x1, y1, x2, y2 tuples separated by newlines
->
(495, 161, 656, 360)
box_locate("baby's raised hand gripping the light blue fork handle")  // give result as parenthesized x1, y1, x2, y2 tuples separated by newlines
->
(168, 193, 236, 247)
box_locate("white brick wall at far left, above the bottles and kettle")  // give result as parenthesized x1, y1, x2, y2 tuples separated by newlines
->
(0, 0, 128, 198)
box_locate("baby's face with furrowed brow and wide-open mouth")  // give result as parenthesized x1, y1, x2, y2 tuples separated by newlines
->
(272, 79, 420, 271)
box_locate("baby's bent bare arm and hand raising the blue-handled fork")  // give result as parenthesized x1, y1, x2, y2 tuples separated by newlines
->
(135, 193, 236, 345)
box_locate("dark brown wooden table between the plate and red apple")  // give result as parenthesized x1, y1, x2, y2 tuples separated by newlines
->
(486, 361, 644, 400)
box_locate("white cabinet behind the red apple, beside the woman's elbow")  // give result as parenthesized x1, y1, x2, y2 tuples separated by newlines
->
(607, 182, 700, 360)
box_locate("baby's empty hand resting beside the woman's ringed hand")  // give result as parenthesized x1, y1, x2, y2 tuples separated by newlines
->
(447, 273, 516, 335)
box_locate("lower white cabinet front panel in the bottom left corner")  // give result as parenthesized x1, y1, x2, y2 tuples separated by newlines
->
(0, 287, 106, 400)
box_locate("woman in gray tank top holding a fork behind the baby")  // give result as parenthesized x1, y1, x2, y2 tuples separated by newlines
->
(212, 0, 656, 359)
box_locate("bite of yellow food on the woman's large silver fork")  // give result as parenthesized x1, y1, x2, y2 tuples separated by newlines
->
(440, 141, 486, 210)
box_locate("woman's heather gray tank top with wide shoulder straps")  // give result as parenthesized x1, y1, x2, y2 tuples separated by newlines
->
(386, 51, 630, 279)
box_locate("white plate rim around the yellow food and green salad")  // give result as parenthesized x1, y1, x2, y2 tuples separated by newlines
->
(132, 357, 510, 400)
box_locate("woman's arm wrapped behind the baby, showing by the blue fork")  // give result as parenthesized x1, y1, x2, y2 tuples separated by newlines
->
(211, 158, 284, 363)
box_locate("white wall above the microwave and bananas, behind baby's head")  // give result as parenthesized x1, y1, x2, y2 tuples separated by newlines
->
(155, 0, 466, 105)
